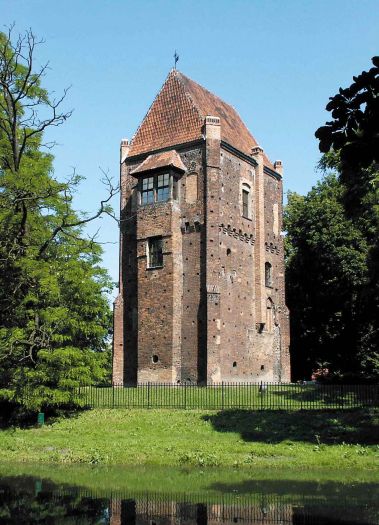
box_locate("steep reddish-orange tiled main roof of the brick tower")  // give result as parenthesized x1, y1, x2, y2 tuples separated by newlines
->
(129, 69, 273, 168)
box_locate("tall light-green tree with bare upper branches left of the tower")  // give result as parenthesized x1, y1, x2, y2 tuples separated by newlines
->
(0, 30, 117, 408)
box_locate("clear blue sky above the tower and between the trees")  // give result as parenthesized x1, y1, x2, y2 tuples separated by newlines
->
(0, 0, 379, 290)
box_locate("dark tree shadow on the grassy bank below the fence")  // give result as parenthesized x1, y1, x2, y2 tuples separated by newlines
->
(203, 409, 379, 445)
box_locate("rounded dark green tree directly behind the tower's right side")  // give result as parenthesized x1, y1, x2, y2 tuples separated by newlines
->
(284, 175, 367, 379)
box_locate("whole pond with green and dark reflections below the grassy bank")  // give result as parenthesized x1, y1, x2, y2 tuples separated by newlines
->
(0, 465, 379, 525)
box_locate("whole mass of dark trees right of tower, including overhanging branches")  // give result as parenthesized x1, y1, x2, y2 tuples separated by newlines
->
(285, 57, 379, 377)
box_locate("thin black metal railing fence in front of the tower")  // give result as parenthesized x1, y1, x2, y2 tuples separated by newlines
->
(76, 382, 379, 410)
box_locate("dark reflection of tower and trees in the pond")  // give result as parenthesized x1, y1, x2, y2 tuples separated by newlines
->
(0, 476, 379, 525)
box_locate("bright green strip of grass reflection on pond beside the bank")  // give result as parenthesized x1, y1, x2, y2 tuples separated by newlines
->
(0, 463, 379, 504)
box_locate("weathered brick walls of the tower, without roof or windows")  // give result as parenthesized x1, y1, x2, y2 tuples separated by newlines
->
(113, 126, 290, 384)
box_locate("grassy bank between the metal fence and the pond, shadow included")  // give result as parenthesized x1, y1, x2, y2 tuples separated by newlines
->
(0, 409, 379, 471)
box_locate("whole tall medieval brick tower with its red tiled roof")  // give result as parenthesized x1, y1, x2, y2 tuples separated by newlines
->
(113, 69, 290, 384)
